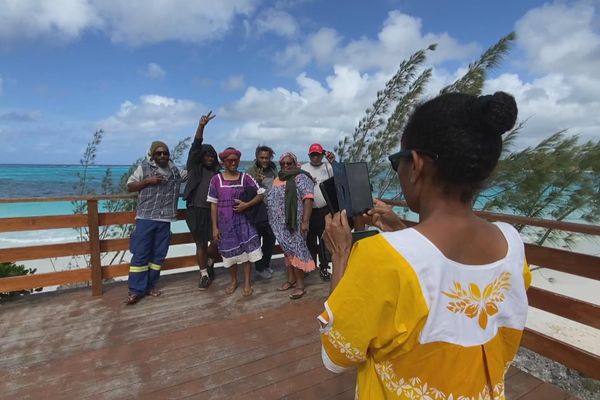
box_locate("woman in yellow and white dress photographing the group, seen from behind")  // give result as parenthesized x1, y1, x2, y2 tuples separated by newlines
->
(318, 92, 531, 400)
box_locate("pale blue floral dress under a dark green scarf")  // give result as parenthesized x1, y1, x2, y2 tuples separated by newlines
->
(266, 174, 315, 272)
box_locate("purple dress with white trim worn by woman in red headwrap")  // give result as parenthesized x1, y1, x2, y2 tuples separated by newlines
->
(207, 173, 262, 268)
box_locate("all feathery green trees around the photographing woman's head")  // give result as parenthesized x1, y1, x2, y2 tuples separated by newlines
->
(335, 32, 600, 248)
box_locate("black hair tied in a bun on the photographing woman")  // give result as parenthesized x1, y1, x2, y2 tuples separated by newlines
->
(400, 92, 518, 202)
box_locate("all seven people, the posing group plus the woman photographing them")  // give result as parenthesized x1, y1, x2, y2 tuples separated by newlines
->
(128, 92, 531, 400)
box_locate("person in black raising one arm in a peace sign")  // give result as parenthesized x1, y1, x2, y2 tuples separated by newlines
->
(183, 111, 219, 290)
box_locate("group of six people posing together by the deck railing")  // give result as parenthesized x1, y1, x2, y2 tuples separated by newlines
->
(126, 112, 335, 304)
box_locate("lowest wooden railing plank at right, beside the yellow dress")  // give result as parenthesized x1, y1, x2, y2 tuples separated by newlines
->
(521, 328, 600, 379)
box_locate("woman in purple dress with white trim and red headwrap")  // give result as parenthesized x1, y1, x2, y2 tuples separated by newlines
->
(207, 147, 264, 296)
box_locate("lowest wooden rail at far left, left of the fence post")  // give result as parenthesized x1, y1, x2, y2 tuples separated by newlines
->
(0, 268, 91, 292)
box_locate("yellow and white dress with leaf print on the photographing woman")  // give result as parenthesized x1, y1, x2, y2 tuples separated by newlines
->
(318, 223, 531, 400)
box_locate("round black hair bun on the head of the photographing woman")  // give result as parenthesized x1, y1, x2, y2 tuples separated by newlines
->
(474, 92, 518, 135)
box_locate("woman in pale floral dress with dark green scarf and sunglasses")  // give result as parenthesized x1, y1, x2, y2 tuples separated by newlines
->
(267, 153, 315, 300)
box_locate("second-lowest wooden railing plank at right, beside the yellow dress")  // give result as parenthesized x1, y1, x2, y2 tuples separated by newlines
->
(527, 287, 600, 329)
